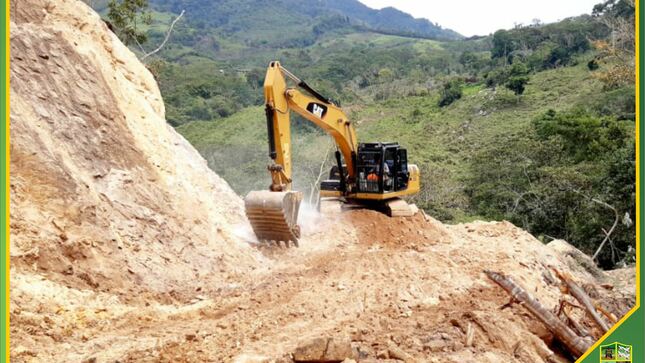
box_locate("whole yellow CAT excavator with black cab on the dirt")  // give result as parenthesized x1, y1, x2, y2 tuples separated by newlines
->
(244, 61, 420, 246)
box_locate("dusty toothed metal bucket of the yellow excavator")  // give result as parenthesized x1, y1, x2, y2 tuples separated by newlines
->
(244, 190, 302, 246)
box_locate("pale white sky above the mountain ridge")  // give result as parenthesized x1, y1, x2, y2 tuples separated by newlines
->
(360, 0, 601, 37)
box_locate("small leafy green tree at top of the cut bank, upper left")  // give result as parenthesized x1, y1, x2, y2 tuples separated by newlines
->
(107, 0, 152, 45)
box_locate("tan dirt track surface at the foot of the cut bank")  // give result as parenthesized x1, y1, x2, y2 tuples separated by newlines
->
(12, 211, 636, 362)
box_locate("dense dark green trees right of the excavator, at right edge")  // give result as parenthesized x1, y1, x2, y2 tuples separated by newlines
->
(467, 108, 636, 268)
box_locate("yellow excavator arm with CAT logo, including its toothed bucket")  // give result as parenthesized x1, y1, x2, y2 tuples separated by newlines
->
(244, 62, 357, 245)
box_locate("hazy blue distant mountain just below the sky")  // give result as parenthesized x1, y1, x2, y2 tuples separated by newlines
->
(151, 0, 463, 42)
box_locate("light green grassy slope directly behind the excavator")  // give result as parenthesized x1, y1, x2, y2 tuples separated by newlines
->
(177, 58, 602, 222)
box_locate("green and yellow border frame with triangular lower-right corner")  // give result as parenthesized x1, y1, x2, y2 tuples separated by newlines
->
(0, 0, 645, 363)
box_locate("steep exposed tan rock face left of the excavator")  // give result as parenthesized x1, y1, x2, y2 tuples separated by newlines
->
(11, 0, 257, 292)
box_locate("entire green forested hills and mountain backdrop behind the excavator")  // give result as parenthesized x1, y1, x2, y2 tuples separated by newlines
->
(99, 0, 635, 268)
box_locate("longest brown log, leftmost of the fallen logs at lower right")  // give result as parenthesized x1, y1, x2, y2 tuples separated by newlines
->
(484, 270, 593, 358)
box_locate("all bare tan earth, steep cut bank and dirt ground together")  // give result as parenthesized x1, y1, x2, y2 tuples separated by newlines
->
(11, 0, 634, 362)
